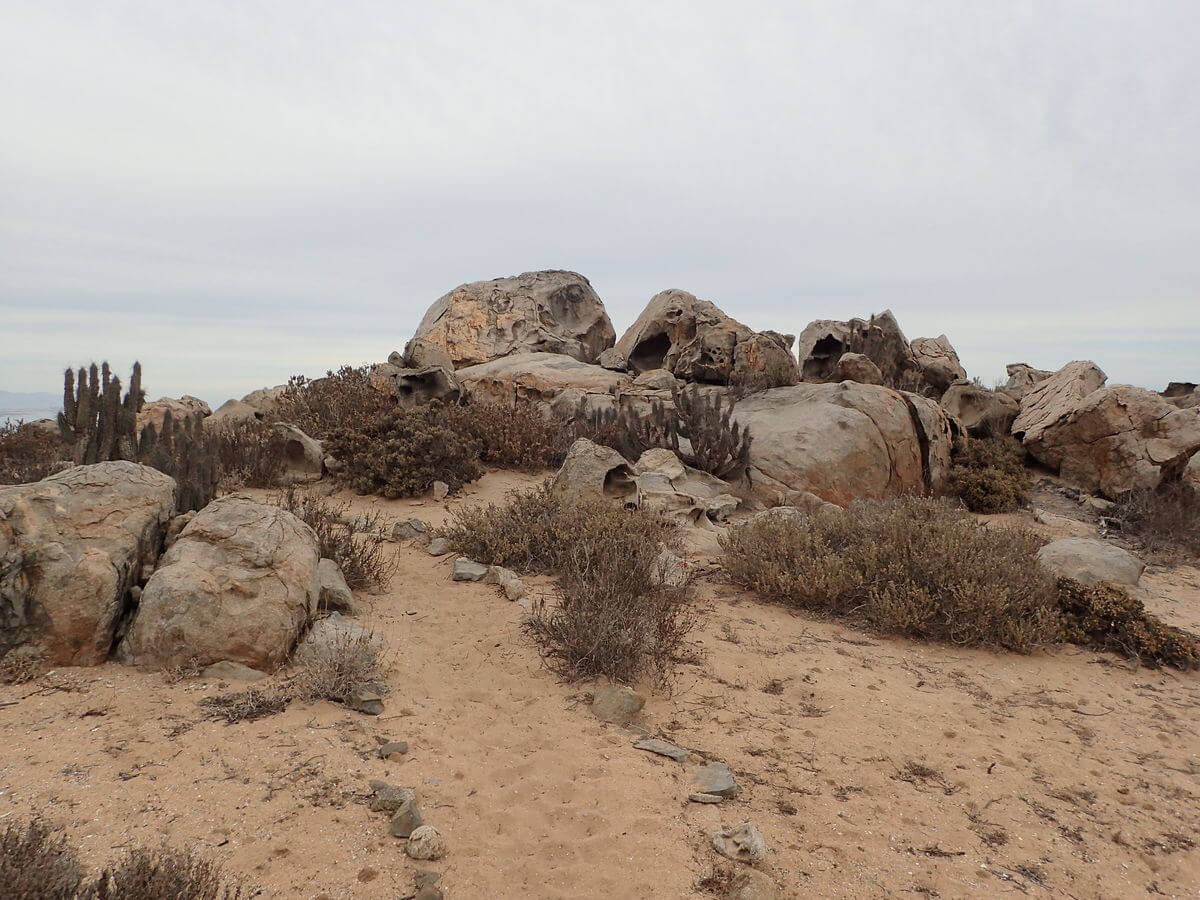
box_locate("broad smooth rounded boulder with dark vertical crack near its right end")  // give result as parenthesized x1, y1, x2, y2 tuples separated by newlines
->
(733, 382, 954, 506)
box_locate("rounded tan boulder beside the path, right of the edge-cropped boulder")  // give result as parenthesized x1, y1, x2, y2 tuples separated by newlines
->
(121, 496, 320, 672)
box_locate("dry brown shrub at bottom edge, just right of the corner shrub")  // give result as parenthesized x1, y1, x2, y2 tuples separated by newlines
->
(89, 847, 250, 900)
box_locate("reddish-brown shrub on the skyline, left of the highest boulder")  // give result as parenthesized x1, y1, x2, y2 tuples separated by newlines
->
(272, 366, 396, 440)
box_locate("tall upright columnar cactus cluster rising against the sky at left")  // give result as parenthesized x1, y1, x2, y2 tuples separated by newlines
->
(58, 362, 145, 466)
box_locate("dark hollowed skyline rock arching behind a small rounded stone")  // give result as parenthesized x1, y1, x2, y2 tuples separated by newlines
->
(796, 310, 922, 390)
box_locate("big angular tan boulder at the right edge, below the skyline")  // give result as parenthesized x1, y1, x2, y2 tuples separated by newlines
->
(1013, 382, 1200, 499)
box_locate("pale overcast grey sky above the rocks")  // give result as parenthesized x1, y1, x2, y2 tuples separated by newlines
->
(0, 0, 1200, 403)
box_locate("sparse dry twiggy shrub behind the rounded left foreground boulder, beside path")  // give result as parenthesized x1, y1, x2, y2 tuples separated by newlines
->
(274, 487, 397, 590)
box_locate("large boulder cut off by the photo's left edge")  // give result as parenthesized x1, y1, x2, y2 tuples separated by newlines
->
(0, 462, 175, 666)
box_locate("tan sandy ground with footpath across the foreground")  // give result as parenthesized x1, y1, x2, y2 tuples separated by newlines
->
(0, 473, 1200, 898)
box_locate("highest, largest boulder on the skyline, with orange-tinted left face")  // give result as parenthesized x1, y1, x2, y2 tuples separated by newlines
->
(404, 271, 616, 368)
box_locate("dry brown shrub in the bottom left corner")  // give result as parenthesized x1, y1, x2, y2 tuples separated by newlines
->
(0, 818, 84, 900)
